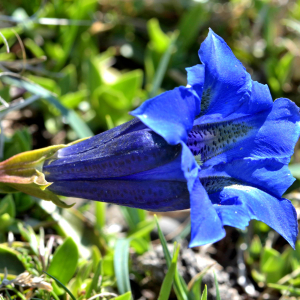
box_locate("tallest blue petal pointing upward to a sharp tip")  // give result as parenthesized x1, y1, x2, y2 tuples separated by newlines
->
(199, 30, 251, 117)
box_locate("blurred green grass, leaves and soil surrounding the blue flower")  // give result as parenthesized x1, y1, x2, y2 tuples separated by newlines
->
(0, 0, 300, 300)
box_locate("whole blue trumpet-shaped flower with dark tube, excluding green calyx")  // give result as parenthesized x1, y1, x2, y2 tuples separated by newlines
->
(43, 31, 300, 247)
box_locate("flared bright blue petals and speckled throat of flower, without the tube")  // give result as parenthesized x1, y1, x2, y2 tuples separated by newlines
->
(133, 31, 300, 247)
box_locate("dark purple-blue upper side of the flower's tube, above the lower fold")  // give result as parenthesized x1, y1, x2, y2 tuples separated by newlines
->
(43, 129, 181, 182)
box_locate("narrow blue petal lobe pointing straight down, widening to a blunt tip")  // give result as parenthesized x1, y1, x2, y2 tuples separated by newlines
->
(189, 179, 226, 247)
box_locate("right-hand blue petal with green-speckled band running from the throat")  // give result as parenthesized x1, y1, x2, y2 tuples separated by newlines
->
(187, 98, 300, 168)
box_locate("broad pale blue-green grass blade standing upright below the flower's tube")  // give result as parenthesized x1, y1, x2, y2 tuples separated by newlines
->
(114, 239, 131, 294)
